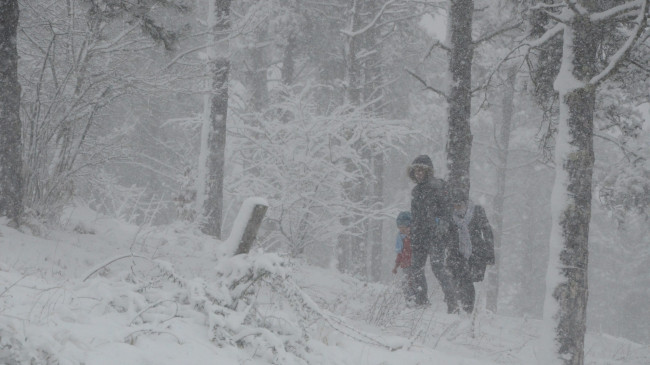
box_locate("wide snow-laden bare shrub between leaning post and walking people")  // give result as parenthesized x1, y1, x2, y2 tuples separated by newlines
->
(227, 85, 413, 256)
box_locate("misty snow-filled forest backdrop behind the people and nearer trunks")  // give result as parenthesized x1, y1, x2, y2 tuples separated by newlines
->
(3, 0, 650, 344)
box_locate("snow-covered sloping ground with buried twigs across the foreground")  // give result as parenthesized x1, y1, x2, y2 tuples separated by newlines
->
(0, 208, 650, 365)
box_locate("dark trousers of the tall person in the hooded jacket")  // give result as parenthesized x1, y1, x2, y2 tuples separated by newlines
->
(411, 245, 456, 313)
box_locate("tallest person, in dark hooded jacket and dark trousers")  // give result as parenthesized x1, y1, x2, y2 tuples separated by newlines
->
(408, 155, 457, 313)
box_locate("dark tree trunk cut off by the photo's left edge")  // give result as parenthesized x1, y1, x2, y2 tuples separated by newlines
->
(0, 0, 23, 225)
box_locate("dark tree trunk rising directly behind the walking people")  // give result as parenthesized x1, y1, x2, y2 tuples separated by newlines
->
(447, 0, 474, 197)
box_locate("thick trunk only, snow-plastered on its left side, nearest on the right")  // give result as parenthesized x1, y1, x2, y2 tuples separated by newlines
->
(542, 14, 602, 365)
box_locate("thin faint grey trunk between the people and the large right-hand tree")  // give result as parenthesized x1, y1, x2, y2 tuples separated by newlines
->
(486, 66, 517, 313)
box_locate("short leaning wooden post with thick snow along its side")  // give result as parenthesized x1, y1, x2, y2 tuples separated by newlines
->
(224, 197, 269, 255)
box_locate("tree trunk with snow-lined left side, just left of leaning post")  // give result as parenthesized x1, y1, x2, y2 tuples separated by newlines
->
(198, 0, 231, 238)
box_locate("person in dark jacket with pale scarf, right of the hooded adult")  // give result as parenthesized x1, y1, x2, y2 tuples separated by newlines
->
(447, 191, 494, 313)
